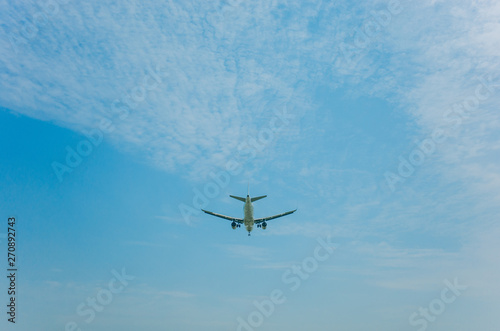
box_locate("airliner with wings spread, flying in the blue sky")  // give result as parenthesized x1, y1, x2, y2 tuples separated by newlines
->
(202, 189, 297, 235)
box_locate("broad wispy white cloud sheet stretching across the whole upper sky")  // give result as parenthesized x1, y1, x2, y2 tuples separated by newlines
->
(0, 1, 500, 187)
